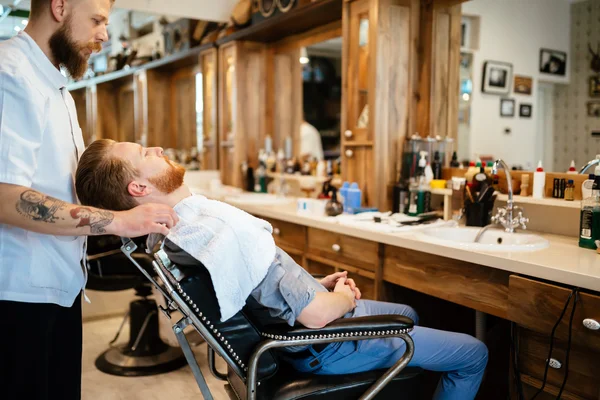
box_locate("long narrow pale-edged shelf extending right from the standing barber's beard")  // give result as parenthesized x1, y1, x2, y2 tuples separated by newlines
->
(67, 43, 214, 91)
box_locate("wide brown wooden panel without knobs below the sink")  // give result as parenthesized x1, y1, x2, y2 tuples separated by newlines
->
(383, 246, 509, 318)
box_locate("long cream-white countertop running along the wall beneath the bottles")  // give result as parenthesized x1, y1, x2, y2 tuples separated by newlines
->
(195, 188, 600, 291)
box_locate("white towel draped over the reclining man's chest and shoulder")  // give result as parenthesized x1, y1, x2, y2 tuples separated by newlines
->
(167, 195, 276, 321)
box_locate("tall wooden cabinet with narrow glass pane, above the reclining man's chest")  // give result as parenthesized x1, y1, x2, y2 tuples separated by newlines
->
(218, 42, 267, 187)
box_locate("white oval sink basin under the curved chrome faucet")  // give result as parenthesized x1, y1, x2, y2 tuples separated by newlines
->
(419, 227, 549, 253)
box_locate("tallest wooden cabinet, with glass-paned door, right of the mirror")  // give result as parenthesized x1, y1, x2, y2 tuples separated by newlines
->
(342, 0, 420, 210)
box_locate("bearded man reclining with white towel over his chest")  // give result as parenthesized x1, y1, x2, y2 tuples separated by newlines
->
(76, 139, 487, 400)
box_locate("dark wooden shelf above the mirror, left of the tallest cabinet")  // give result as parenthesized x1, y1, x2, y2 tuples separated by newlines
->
(217, 0, 343, 46)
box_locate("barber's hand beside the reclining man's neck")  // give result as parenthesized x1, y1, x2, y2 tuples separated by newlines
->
(107, 204, 179, 238)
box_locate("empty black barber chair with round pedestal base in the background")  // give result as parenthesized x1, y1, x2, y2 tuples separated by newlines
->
(86, 236, 186, 376)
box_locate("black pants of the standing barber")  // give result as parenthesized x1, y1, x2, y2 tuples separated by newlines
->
(0, 295, 82, 400)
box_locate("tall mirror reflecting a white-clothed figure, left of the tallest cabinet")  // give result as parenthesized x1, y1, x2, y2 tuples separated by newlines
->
(300, 37, 342, 160)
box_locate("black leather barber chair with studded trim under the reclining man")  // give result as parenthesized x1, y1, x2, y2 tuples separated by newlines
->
(122, 238, 422, 400)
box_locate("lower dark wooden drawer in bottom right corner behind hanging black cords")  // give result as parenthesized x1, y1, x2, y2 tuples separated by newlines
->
(519, 329, 600, 399)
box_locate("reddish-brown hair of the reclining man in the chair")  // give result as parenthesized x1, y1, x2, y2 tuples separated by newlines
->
(75, 139, 138, 211)
